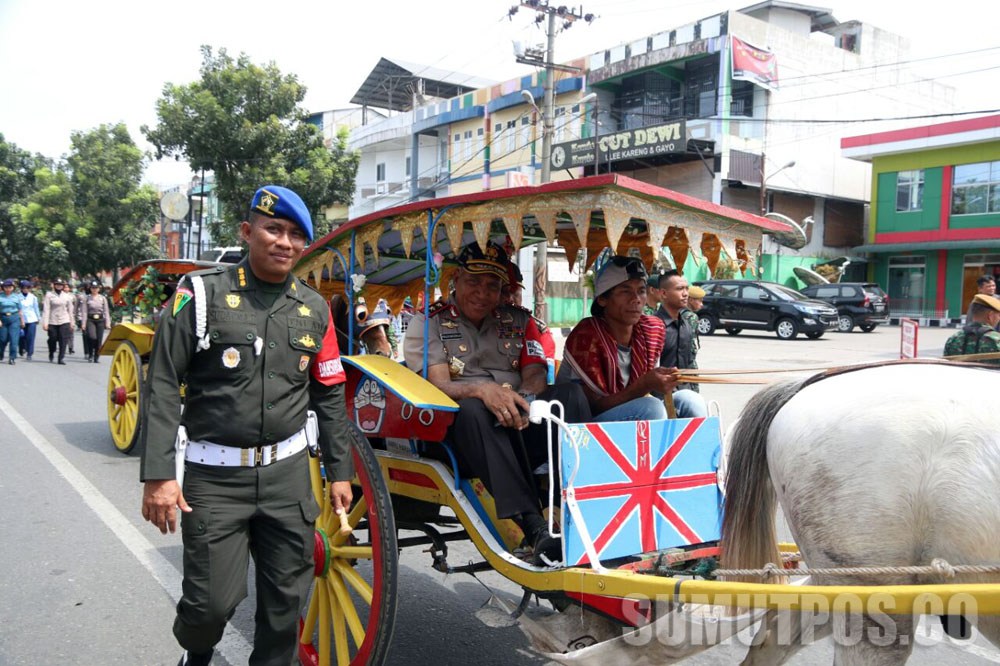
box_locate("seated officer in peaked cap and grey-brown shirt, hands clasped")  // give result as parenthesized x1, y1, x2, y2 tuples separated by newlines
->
(403, 241, 590, 561)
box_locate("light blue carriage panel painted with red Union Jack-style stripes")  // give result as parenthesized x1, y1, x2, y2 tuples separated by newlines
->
(561, 417, 722, 565)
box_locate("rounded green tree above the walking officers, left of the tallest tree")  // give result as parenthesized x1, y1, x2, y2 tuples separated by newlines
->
(68, 123, 159, 275)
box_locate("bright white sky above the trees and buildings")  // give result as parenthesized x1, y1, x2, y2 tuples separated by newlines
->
(0, 0, 1000, 187)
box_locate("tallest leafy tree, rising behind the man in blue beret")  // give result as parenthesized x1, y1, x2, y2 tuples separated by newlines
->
(142, 46, 359, 245)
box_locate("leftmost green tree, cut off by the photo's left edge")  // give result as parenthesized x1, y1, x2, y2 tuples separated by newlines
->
(0, 134, 49, 277)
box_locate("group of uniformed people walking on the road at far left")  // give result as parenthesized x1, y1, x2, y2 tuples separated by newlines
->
(0, 278, 111, 365)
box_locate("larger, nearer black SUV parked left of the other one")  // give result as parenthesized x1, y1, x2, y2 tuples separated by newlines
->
(695, 280, 837, 340)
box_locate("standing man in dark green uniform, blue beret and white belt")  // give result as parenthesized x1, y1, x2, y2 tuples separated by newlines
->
(141, 186, 355, 666)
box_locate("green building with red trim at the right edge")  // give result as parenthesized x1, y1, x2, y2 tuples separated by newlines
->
(841, 115, 1000, 324)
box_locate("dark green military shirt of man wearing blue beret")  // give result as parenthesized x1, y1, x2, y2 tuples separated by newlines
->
(142, 260, 351, 480)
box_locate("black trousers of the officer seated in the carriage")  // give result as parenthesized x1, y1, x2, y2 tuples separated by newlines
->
(448, 384, 590, 518)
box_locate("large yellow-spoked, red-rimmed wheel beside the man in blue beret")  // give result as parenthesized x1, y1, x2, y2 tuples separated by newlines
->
(299, 426, 399, 666)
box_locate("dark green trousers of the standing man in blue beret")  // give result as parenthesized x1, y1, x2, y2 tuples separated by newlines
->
(174, 451, 319, 666)
